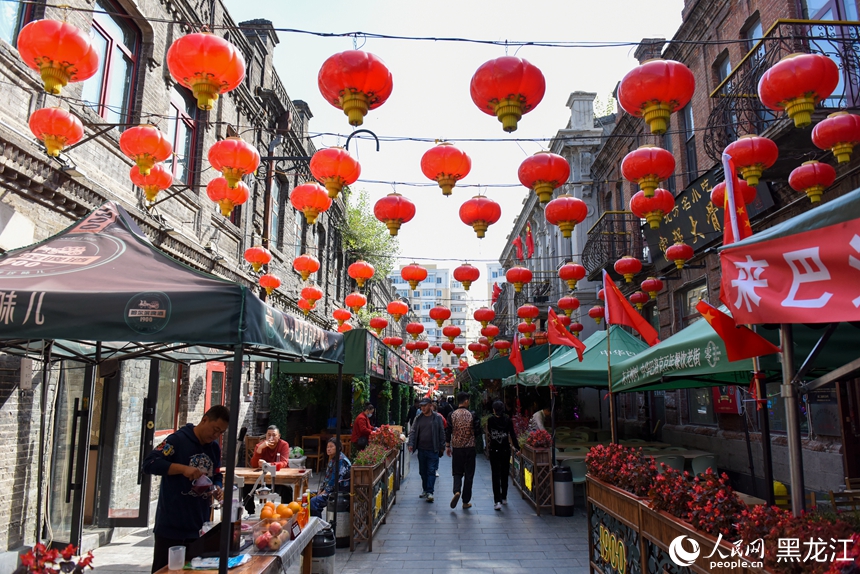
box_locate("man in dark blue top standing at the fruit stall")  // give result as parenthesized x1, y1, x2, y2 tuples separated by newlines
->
(143, 405, 230, 572)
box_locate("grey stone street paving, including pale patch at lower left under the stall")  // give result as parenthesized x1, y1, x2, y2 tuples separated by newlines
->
(94, 455, 588, 574)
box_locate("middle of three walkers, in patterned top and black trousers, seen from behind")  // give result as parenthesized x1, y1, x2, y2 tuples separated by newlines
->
(445, 392, 481, 509)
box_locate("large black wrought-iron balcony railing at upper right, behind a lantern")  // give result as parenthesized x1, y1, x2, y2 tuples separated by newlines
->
(704, 20, 860, 162)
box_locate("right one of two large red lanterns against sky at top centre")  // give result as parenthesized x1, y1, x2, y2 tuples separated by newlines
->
(469, 56, 546, 132)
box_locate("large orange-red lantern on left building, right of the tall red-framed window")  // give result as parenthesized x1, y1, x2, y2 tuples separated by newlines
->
(167, 32, 245, 110)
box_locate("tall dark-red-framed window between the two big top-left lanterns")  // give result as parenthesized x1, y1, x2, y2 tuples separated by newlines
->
(81, 0, 140, 124)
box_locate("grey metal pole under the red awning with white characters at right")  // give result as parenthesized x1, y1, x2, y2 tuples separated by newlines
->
(779, 323, 806, 516)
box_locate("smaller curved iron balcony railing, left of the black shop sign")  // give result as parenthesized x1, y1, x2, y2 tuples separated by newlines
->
(582, 211, 645, 280)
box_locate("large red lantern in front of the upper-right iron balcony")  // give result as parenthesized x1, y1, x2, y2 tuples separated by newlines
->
(758, 54, 840, 128)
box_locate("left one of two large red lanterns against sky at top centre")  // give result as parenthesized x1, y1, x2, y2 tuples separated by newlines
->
(317, 50, 394, 126)
